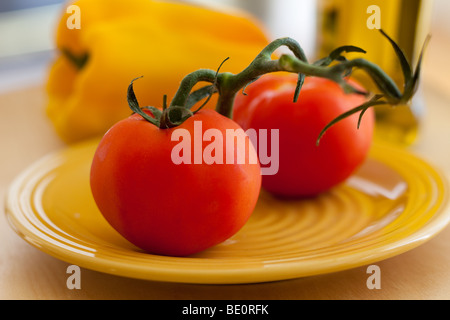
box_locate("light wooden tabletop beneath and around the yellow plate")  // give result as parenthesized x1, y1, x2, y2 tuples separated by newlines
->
(0, 30, 450, 300)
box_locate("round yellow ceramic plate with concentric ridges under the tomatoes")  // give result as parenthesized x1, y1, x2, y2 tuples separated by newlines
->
(6, 141, 450, 284)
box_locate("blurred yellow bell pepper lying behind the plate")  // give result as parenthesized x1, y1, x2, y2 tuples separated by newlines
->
(47, 0, 269, 143)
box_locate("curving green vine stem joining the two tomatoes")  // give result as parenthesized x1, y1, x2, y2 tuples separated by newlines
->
(128, 30, 429, 142)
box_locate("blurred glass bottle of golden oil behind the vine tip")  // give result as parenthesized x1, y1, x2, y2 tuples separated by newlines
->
(317, 0, 432, 145)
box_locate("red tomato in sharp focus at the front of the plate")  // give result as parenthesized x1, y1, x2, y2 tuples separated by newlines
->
(90, 110, 261, 256)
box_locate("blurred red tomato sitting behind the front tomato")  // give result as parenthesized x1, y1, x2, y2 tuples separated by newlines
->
(233, 74, 374, 197)
